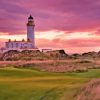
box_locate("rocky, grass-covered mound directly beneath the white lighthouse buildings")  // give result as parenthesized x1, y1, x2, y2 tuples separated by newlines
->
(0, 50, 68, 61)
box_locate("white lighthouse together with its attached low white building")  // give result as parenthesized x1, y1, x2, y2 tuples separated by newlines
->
(5, 15, 35, 50)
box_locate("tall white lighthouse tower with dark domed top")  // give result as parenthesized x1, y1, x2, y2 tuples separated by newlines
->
(27, 15, 35, 48)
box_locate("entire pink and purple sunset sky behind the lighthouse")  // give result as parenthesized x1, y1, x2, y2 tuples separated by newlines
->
(0, 0, 100, 53)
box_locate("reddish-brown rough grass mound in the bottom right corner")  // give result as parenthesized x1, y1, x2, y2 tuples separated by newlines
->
(77, 79, 100, 100)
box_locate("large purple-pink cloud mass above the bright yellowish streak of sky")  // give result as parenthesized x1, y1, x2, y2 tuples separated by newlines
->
(0, 0, 100, 33)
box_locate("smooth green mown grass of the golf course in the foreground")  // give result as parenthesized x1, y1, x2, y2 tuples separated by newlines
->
(0, 68, 100, 100)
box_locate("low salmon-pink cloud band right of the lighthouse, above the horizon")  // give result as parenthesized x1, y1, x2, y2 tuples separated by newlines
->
(36, 39, 100, 53)
